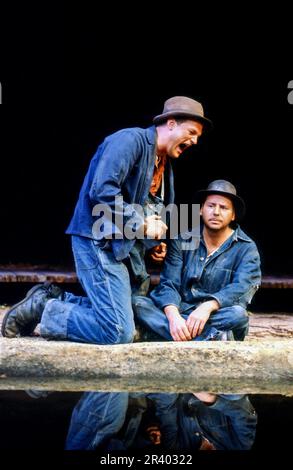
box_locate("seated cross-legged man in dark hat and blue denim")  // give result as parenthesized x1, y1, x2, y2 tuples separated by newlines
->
(134, 180, 261, 341)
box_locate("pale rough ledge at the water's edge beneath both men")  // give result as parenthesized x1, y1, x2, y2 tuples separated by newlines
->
(0, 338, 293, 395)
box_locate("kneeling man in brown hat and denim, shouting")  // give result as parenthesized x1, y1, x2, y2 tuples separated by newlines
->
(2, 96, 211, 344)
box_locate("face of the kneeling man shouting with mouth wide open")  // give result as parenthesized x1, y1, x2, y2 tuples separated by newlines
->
(167, 119, 203, 158)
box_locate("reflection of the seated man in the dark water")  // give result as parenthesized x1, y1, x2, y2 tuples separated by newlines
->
(161, 392, 257, 451)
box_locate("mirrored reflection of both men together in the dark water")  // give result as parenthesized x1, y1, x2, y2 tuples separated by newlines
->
(66, 392, 257, 452)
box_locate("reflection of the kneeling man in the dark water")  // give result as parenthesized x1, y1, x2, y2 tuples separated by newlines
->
(66, 392, 162, 452)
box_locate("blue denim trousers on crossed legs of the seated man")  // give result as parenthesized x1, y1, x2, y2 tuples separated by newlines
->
(133, 296, 248, 341)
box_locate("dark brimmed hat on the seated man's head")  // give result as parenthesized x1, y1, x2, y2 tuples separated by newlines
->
(195, 180, 245, 221)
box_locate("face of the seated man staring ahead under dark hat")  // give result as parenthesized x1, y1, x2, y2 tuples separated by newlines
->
(200, 194, 235, 231)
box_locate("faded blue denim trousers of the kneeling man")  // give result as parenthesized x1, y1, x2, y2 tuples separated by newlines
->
(40, 236, 135, 344)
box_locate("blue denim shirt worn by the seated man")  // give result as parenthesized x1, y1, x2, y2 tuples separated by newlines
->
(150, 226, 261, 312)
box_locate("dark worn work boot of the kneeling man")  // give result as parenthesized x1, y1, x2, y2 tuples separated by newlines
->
(1, 282, 63, 338)
